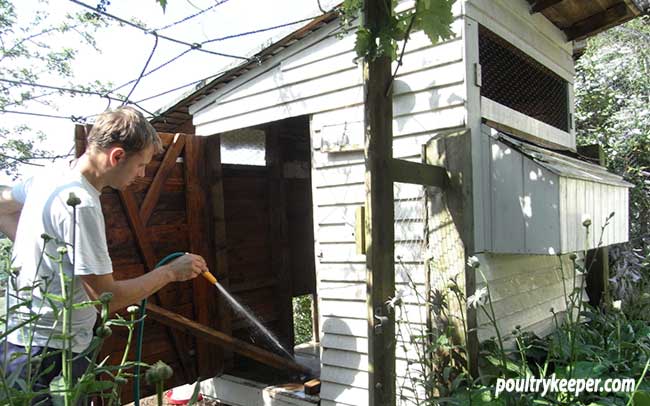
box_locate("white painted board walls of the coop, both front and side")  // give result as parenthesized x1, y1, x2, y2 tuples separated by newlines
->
(190, 0, 628, 406)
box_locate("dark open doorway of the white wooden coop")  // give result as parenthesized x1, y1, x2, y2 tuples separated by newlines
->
(215, 116, 319, 384)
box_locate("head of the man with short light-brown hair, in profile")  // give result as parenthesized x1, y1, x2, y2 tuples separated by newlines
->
(88, 107, 162, 190)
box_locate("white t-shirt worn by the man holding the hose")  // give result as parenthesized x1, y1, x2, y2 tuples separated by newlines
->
(8, 165, 113, 352)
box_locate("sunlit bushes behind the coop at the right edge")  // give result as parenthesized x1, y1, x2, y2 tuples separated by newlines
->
(575, 16, 650, 320)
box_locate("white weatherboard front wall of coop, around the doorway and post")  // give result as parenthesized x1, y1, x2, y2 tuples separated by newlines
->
(190, 6, 466, 406)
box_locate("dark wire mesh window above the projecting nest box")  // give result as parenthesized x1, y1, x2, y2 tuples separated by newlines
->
(479, 26, 569, 131)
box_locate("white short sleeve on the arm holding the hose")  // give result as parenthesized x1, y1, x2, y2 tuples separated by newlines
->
(67, 206, 113, 275)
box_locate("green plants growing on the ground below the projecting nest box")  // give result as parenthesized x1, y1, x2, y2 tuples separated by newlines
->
(396, 236, 650, 406)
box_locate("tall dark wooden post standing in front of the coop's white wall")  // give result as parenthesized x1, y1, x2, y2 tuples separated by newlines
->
(363, 0, 396, 406)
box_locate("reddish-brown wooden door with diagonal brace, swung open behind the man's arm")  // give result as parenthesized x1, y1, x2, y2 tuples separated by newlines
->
(75, 126, 230, 401)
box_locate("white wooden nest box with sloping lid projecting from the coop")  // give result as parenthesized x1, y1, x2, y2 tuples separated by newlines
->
(481, 125, 630, 255)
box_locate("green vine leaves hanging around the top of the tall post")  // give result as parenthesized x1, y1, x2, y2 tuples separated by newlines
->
(341, 0, 455, 61)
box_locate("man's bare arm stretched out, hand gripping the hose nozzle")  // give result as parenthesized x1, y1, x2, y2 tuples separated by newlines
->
(80, 254, 208, 312)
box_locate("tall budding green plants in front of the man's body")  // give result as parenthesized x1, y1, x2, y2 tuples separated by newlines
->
(0, 194, 159, 406)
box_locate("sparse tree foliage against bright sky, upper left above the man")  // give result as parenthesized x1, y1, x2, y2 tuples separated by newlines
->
(0, 0, 108, 175)
